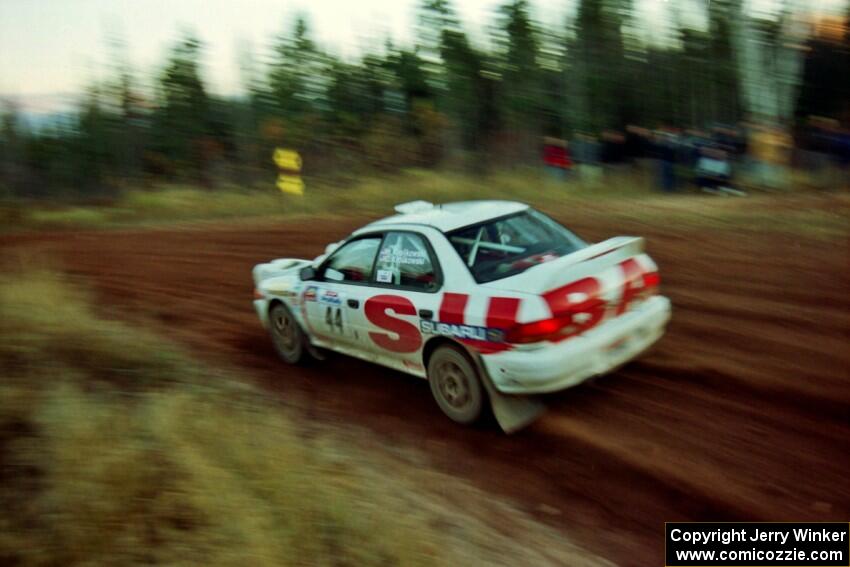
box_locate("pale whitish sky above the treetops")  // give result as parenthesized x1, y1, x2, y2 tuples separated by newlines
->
(0, 0, 844, 112)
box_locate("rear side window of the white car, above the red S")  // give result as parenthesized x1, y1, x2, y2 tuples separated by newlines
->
(375, 232, 439, 291)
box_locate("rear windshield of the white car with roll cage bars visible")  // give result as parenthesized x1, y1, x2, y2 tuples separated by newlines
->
(446, 209, 586, 283)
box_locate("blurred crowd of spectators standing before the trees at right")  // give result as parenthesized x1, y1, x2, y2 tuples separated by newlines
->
(543, 118, 850, 195)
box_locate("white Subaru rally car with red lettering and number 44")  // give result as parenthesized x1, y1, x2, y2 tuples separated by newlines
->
(253, 201, 670, 430)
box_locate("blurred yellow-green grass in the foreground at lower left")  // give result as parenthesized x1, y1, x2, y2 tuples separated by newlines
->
(0, 265, 444, 566)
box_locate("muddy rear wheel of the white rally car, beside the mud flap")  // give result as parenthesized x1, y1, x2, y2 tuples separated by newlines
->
(428, 345, 486, 425)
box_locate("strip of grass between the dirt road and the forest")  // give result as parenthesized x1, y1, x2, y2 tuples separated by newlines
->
(0, 170, 850, 238)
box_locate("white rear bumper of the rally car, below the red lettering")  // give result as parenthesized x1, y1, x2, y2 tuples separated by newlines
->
(481, 296, 671, 394)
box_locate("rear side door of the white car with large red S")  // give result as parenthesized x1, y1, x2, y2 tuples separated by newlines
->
(353, 230, 443, 374)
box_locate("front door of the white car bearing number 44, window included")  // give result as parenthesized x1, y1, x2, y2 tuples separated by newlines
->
(302, 235, 381, 354)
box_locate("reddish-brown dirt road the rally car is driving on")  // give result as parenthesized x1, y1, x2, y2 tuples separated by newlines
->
(0, 213, 850, 566)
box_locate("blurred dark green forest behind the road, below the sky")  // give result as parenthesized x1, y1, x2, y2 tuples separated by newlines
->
(0, 0, 850, 199)
